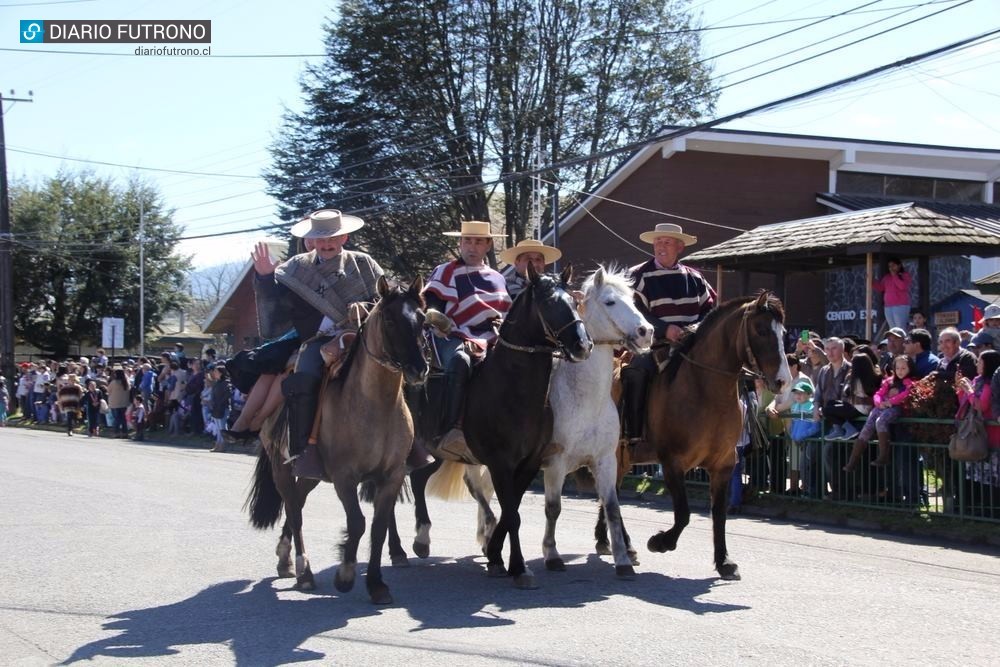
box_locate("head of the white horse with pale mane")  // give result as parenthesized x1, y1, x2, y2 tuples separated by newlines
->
(581, 266, 653, 352)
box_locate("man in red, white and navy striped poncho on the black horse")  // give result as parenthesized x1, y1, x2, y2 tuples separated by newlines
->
(424, 221, 511, 460)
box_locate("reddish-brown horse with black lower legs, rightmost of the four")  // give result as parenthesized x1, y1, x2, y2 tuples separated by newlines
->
(646, 292, 792, 579)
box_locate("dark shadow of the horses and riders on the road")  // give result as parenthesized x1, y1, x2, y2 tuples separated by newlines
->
(61, 555, 748, 665)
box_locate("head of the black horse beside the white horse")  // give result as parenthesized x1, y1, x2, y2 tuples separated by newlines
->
(505, 264, 594, 361)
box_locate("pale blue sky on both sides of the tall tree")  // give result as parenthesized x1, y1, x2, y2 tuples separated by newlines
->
(0, 0, 1000, 266)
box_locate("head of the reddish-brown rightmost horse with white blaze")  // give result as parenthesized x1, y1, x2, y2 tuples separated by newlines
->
(741, 291, 793, 393)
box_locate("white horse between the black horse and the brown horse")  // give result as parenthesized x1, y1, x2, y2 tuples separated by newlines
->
(424, 266, 653, 577)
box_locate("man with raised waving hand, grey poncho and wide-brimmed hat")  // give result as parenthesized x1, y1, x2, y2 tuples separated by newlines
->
(251, 209, 383, 479)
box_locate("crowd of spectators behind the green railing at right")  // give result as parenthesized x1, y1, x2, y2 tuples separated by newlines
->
(757, 305, 1000, 507)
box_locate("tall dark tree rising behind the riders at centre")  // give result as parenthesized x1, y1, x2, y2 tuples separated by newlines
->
(267, 0, 715, 273)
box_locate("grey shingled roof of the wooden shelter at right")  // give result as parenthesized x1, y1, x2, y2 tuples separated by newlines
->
(685, 202, 1000, 273)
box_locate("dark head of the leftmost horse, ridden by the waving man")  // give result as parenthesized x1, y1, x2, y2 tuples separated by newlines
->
(366, 276, 430, 385)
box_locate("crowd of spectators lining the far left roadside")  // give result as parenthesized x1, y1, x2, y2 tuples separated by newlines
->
(0, 343, 243, 449)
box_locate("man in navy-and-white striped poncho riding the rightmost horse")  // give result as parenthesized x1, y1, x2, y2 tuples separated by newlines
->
(622, 222, 717, 461)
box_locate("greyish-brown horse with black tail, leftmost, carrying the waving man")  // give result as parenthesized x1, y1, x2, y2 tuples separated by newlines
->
(247, 278, 428, 604)
